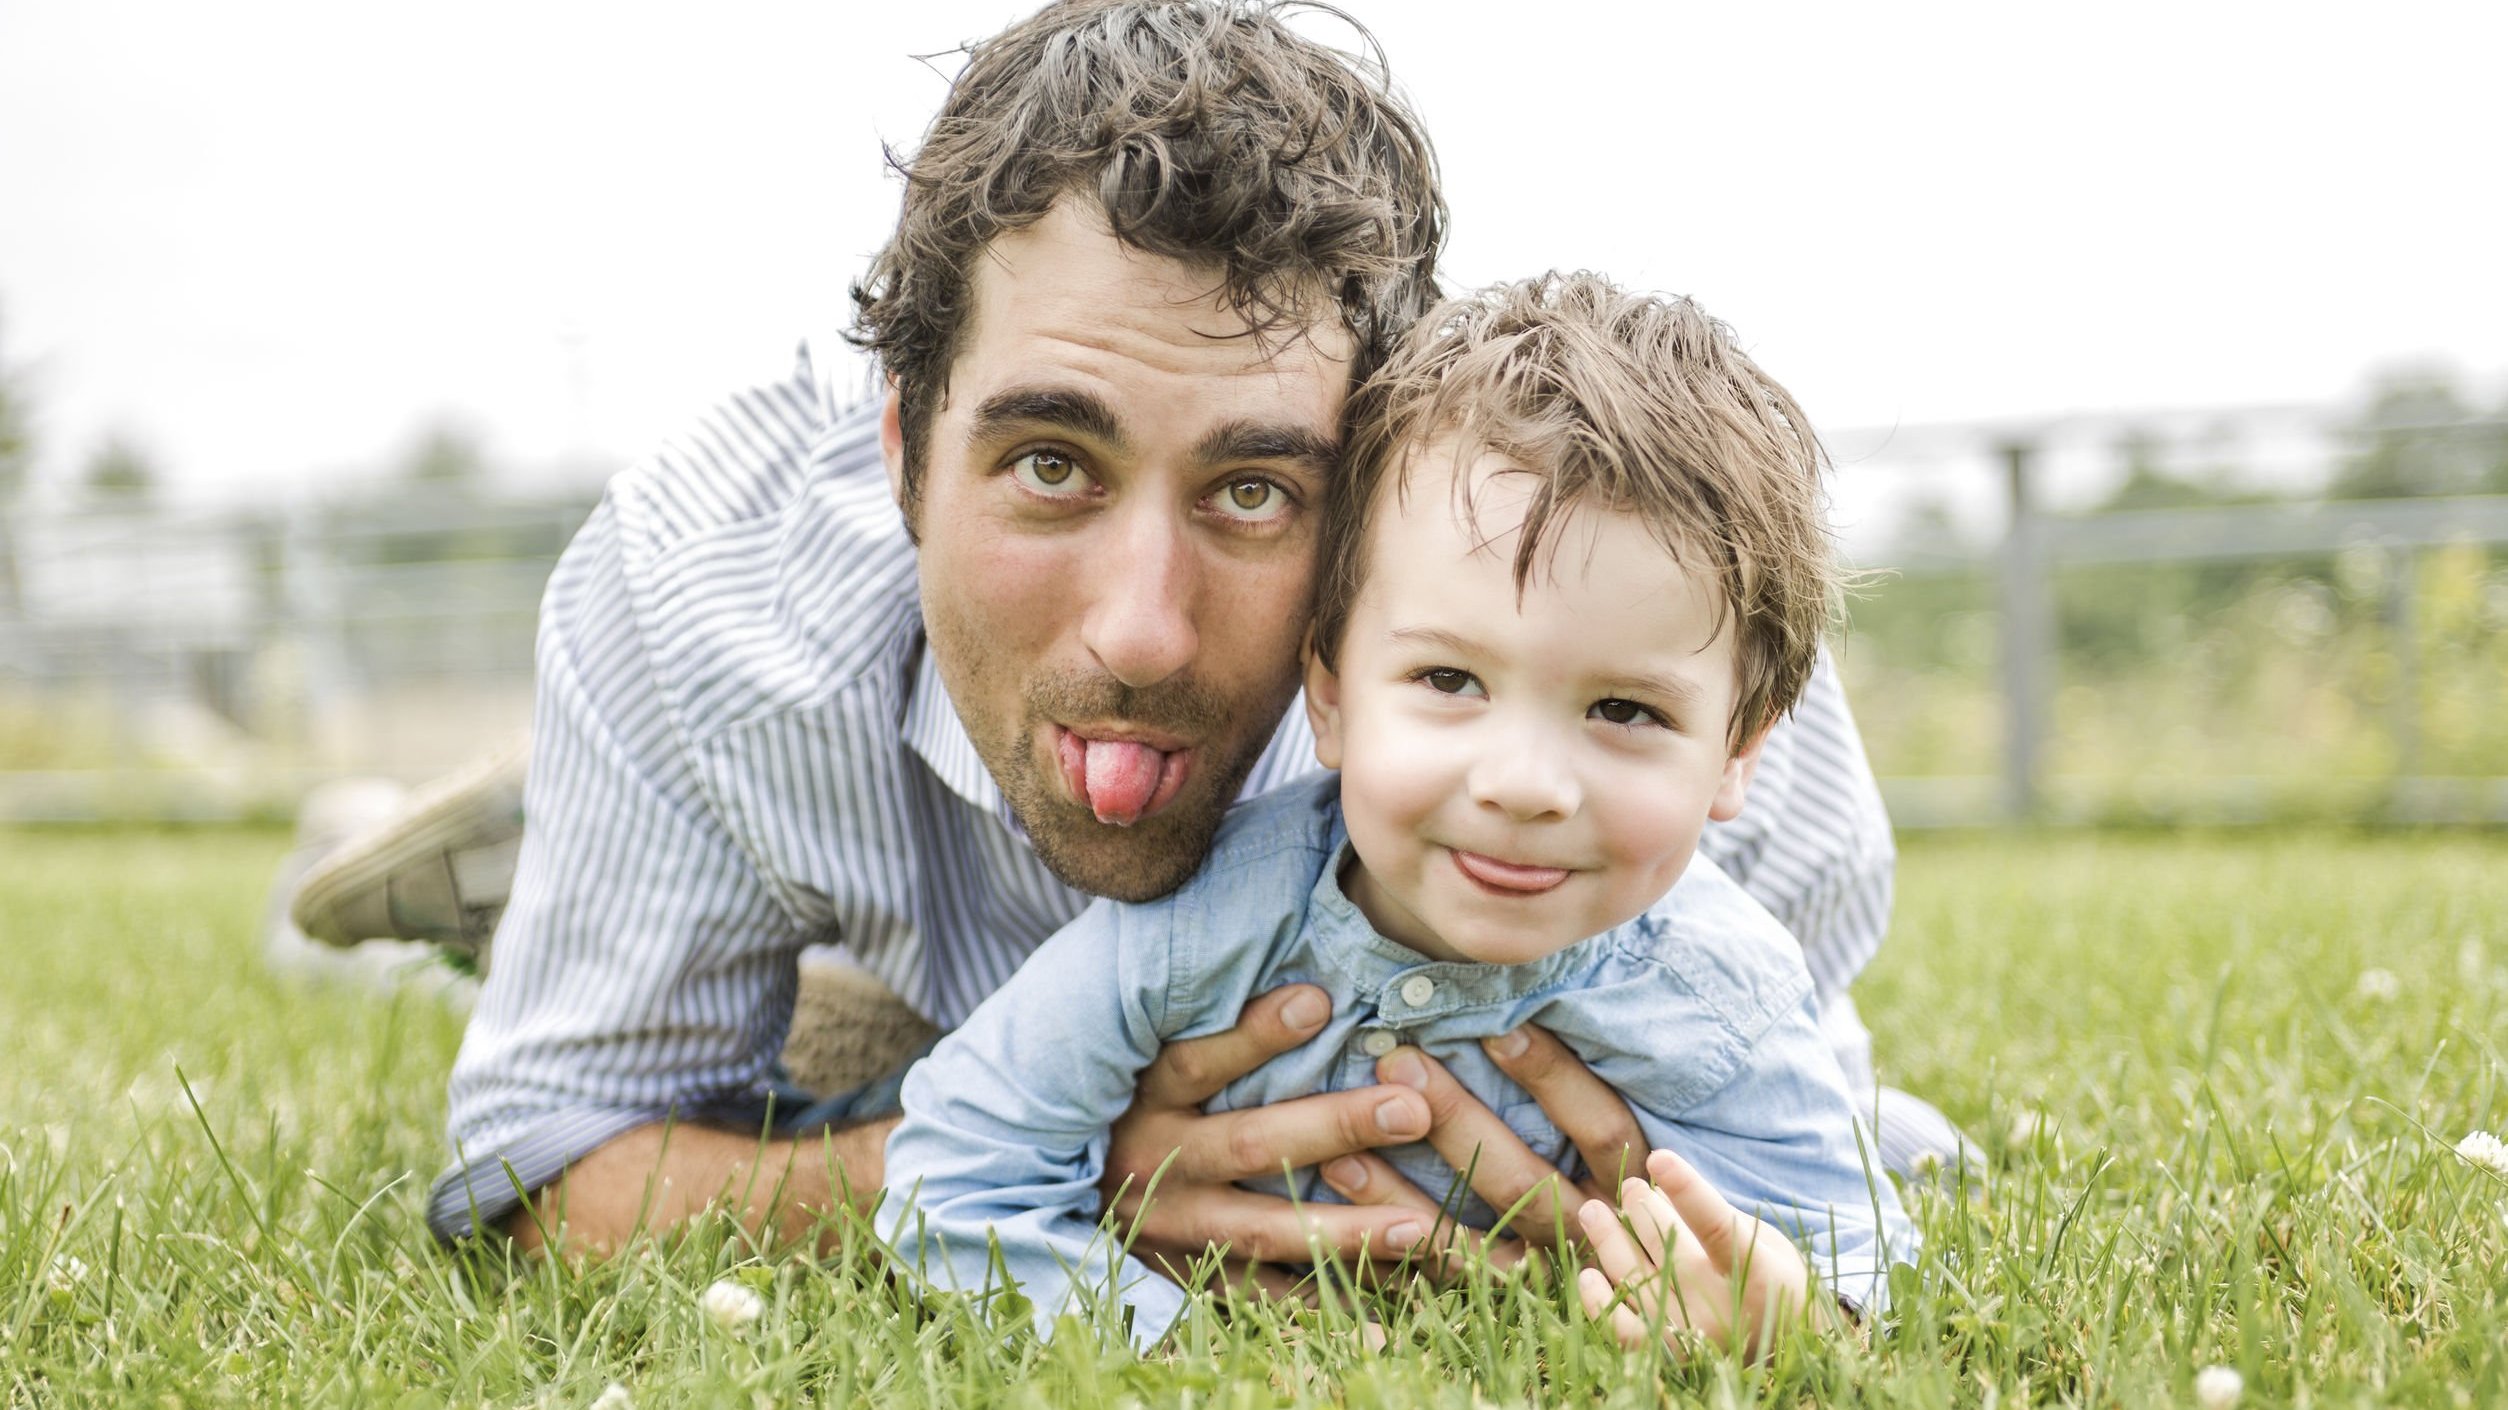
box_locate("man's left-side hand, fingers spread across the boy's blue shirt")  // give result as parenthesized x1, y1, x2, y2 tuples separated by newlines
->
(1101, 983, 1435, 1292)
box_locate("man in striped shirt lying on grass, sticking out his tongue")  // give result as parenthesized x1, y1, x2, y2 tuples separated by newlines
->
(298, 0, 1936, 1264)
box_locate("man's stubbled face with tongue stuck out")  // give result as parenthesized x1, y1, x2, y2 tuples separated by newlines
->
(883, 201, 1349, 901)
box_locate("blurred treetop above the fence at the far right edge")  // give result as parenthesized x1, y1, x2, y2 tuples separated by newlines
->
(2327, 366, 2508, 499)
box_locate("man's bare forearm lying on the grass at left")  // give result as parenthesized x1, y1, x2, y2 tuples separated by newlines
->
(507, 1116, 898, 1254)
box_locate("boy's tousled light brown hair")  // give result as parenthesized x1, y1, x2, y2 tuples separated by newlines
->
(1314, 273, 1838, 748)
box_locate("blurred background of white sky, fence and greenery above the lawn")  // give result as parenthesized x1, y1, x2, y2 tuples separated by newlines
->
(0, 0, 2508, 825)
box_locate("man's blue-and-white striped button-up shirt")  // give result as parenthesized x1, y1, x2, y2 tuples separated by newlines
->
(429, 346, 1891, 1239)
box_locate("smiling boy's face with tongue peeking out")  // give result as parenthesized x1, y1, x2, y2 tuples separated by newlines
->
(1307, 442, 1761, 963)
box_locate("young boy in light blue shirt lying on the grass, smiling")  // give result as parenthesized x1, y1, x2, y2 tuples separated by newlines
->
(883, 276, 1914, 1345)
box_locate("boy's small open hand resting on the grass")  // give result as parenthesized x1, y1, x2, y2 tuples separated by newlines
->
(1575, 1152, 1821, 1357)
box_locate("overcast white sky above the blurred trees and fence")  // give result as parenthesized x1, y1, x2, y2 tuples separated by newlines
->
(0, 0, 2508, 497)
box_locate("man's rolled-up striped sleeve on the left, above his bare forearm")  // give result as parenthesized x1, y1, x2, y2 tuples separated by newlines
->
(426, 502, 818, 1242)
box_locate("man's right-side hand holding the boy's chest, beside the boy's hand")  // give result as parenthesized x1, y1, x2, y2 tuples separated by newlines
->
(1324, 1024, 1645, 1267)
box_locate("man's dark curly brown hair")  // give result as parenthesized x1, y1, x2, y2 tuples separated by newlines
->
(853, 0, 1447, 504)
